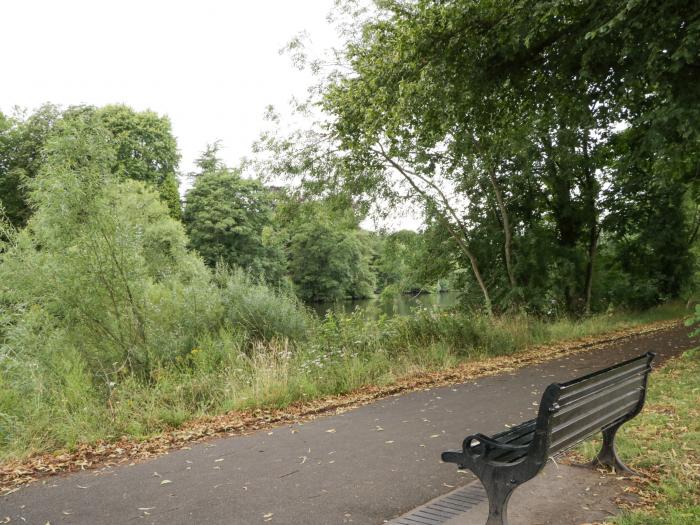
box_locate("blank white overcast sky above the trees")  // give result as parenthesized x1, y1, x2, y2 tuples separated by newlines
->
(0, 0, 337, 172)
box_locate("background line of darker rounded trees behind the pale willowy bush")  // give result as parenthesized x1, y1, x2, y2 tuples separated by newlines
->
(0, 104, 442, 302)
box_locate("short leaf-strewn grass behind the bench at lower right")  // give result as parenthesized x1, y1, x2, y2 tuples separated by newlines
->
(582, 349, 700, 525)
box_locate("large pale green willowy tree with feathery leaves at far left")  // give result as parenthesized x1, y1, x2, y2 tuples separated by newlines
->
(0, 114, 218, 376)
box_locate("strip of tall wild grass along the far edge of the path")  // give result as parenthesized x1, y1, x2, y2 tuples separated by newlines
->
(0, 305, 684, 461)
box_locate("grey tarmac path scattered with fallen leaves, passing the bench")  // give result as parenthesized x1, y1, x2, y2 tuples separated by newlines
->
(0, 327, 692, 525)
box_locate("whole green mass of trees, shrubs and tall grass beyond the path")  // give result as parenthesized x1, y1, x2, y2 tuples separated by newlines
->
(0, 0, 700, 456)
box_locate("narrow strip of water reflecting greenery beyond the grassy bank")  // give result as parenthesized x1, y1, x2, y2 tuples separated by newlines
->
(311, 292, 459, 317)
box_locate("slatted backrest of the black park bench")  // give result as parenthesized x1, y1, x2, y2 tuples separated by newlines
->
(533, 353, 655, 456)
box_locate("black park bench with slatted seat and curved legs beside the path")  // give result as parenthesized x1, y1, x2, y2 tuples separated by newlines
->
(442, 353, 655, 525)
